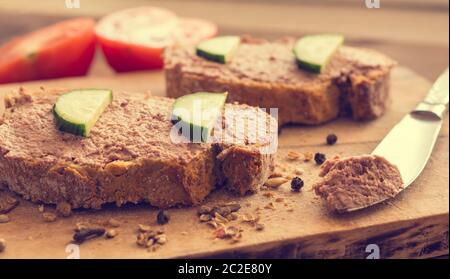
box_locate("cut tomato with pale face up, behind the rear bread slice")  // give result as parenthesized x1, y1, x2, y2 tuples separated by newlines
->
(95, 7, 217, 72)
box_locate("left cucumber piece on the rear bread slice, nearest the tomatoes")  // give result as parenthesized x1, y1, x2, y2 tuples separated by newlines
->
(196, 36, 241, 64)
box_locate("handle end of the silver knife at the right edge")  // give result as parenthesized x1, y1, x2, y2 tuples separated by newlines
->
(413, 68, 449, 119)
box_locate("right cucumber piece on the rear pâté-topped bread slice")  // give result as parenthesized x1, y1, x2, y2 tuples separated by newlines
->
(294, 34, 344, 73)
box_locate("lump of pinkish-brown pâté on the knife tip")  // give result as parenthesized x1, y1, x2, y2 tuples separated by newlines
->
(313, 155, 403, 212)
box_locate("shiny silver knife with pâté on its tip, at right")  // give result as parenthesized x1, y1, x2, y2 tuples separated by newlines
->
(347, 68, 449, 212)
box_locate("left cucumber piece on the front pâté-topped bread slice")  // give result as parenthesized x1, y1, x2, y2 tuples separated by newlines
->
(53, 89, 113, 137)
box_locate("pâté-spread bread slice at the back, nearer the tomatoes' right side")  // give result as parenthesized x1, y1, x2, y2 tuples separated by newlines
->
(165, 38, 395, 125)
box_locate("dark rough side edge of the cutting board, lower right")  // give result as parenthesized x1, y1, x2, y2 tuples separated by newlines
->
(178, 213, 449, 259)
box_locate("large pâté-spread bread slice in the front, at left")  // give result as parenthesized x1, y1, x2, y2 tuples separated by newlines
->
(0, 89, 277, 208)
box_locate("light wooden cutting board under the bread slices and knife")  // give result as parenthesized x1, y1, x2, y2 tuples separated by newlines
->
(0, 67, 449, 258)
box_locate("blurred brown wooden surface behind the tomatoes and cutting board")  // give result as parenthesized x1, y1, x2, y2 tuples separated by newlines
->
(0, 0, 449, 79)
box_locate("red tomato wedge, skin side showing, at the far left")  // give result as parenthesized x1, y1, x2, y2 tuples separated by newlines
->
(0, 18, 96, 83)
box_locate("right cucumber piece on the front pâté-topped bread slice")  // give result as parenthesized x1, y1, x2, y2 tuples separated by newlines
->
(172, 92, 228, 142)
